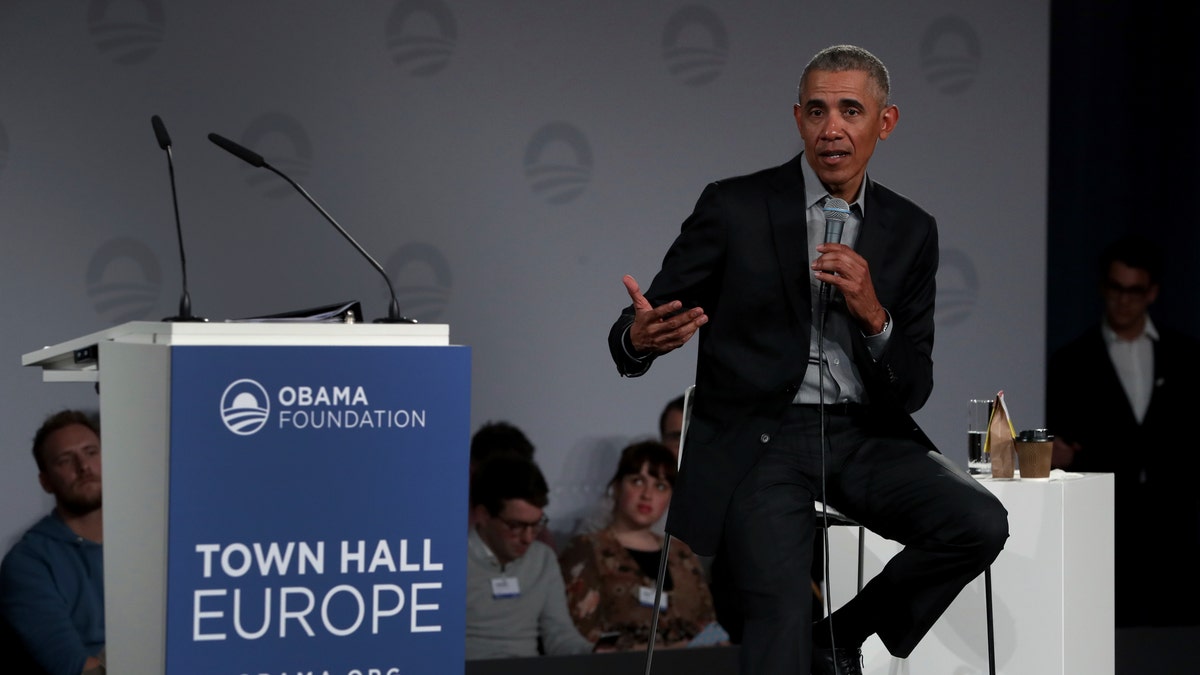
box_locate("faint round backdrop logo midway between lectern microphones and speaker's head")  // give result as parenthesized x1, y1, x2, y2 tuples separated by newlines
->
(524, 121, 592, 205)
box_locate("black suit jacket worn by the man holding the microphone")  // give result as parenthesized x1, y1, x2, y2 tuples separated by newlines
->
(608, 155, 938, 555)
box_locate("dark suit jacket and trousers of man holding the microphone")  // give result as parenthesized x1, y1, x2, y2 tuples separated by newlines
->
(608, 155, 1008, 673)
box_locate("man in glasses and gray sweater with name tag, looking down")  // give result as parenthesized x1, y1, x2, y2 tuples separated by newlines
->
(467, 455, 593, 659)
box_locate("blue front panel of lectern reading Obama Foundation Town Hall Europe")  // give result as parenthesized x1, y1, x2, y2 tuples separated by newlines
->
(166, 347, 470, 675)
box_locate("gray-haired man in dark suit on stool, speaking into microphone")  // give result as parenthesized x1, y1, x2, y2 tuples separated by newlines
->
(608, 46, 1008, 675)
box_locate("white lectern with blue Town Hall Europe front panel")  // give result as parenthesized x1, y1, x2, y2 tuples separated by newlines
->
(22, 322, 470, 675)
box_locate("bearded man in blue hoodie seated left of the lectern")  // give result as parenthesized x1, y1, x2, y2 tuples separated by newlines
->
(0, 410, 104, 675)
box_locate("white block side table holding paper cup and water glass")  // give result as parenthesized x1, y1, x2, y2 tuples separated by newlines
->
(829, 473, 1115, 675)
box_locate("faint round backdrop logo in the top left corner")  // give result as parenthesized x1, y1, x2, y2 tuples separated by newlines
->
(88, 0, 167, 66)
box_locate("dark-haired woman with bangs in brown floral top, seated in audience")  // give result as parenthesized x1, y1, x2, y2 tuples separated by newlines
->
(559, 441, 727, 651)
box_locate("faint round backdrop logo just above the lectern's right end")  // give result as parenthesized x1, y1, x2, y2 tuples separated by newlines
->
(380, 241, 454, 322)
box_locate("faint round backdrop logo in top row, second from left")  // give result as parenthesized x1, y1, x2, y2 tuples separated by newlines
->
(384, 0, 458, 77)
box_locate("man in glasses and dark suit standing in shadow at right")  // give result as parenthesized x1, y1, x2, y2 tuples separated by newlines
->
(1046, 235, 1200, 627)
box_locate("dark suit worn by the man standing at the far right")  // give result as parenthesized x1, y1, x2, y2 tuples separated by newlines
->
(1046, 324, 1200, 627)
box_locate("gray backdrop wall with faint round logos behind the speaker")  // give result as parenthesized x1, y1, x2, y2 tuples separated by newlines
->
(0, 0, 1049, 549)
